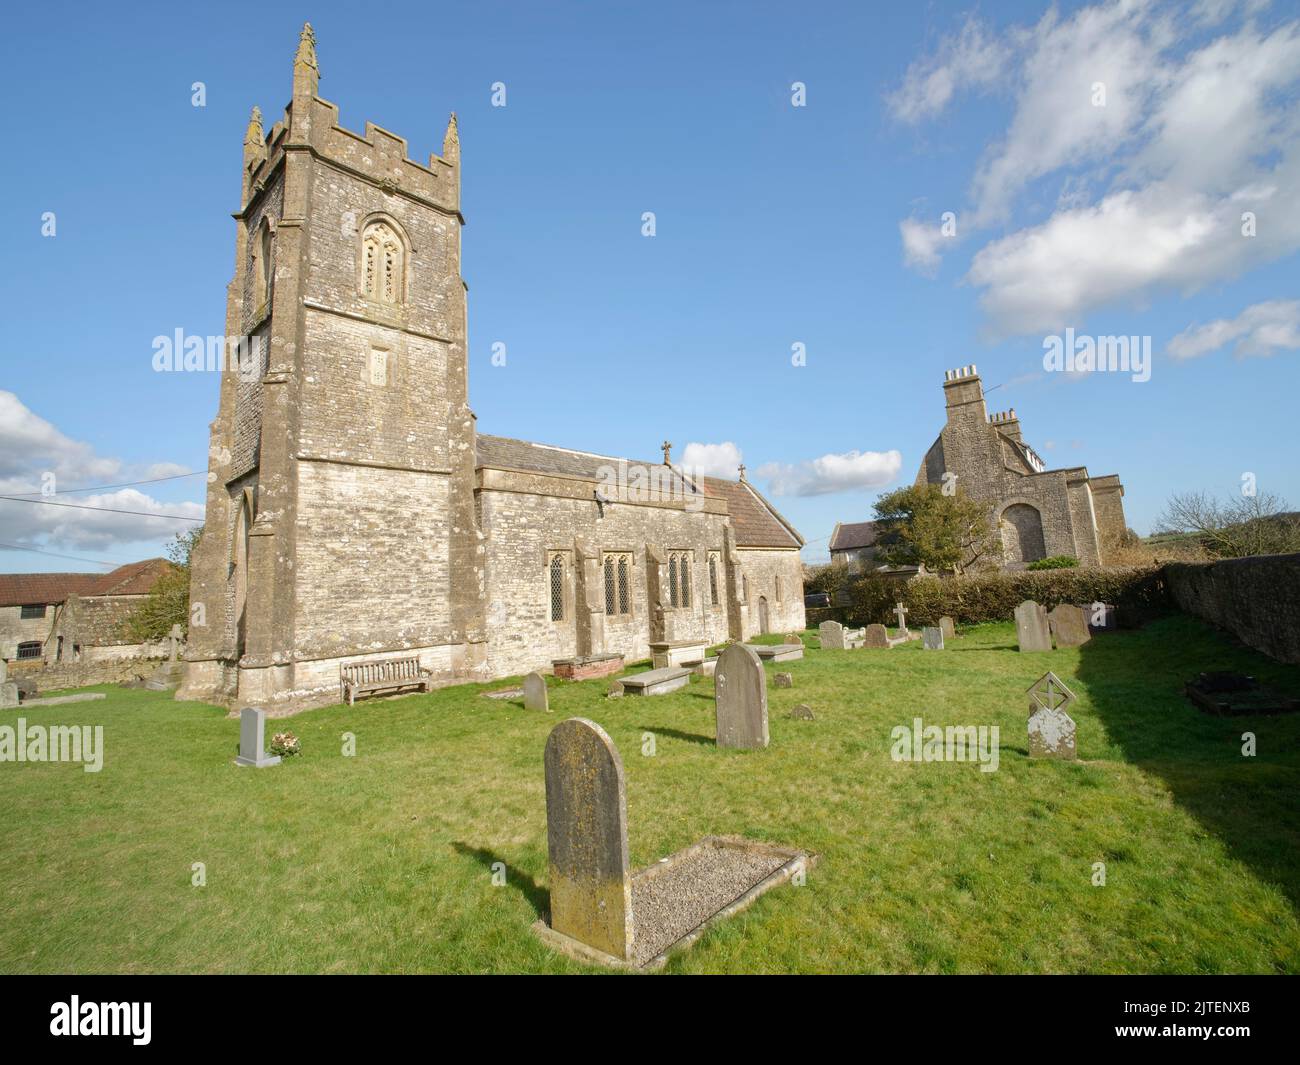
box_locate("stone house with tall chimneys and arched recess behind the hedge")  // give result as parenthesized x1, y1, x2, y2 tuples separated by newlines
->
(917, 364, 1126, 570)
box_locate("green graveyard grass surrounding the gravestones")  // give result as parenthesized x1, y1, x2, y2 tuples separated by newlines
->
(0, 616, 1300, 973)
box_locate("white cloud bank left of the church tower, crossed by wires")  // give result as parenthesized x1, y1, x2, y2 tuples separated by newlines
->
(0, 391, 203, 559)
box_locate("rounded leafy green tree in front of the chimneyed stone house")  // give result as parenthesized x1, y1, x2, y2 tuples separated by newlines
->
(876, 485, 993, 573)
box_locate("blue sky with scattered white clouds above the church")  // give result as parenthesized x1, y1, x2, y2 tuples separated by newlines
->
(0, 0, 1300, 571)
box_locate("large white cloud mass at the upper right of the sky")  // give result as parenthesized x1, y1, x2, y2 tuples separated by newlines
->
(896, 0, 1300, 334)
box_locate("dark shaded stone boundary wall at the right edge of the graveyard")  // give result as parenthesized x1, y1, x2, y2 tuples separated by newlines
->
(1164, 554, 1300, 662)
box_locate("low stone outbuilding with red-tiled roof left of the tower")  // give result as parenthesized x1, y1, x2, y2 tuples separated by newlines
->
(0, 558, 170, 668)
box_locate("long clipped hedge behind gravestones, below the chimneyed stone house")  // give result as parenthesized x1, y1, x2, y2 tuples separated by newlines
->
(849, 566, 1169, 625)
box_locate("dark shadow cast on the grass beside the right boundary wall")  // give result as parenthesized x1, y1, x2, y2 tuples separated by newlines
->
(1078, 615, 1300, 909)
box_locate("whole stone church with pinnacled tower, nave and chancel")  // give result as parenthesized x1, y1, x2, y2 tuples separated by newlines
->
(178, 26, 803, 713)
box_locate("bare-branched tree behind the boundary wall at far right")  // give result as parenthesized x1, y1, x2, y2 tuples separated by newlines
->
(1157, 492, 1300, 558)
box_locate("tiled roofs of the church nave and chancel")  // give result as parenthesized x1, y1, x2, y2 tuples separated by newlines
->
(476, 433, 803, 547)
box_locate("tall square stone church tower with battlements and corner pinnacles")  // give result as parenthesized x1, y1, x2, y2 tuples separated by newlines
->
(179, 25, 485, 705)
